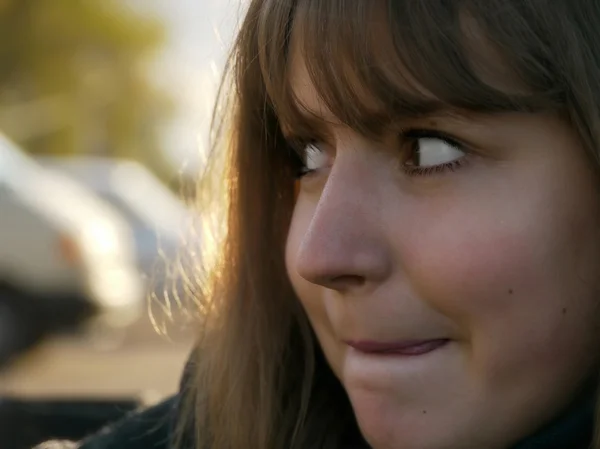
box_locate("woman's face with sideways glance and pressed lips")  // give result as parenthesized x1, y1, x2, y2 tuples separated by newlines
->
(286, 49, 600, 449)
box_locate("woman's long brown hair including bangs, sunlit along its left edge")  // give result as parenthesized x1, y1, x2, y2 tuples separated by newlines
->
(184, 0, 600, 449)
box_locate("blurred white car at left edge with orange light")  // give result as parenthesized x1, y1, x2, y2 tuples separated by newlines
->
(0, 135, 144, 362)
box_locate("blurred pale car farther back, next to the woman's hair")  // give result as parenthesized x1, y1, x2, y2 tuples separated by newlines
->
(38, 156, 199, 298)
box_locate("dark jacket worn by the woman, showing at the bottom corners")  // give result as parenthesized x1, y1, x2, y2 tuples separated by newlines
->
(35, 356, 596, 449)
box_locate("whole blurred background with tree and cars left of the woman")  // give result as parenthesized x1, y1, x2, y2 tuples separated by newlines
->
(0, 0, 244, 449)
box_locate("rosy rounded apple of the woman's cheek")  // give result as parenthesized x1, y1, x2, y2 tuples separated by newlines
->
(401, 213, 543, 319)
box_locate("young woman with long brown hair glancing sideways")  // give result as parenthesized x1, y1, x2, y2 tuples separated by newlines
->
(42, 0, 600, 449)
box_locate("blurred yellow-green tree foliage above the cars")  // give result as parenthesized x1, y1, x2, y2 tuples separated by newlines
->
(0, 0, 172, 166)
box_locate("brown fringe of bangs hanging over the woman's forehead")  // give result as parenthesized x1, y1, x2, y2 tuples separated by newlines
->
(259, 0, 564, 134)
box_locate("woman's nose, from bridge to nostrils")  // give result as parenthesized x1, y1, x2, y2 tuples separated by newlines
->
(296, 158, 392, 293)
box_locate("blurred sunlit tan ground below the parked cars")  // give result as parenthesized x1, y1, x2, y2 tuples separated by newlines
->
(0, 316, 193, 402)
